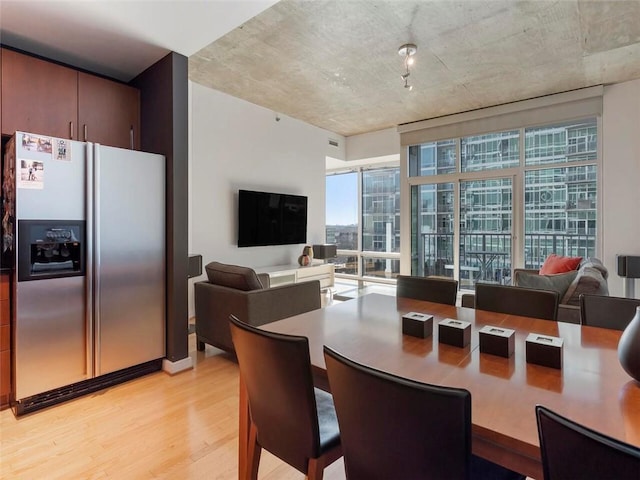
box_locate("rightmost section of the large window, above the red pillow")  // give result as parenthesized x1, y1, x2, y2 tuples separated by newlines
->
(524, 119, 598, 268)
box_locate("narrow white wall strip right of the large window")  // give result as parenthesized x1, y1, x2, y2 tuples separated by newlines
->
(600, 80, 640, 298)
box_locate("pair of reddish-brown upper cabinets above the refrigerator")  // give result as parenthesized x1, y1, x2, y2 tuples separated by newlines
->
(0, 49, 140, 149)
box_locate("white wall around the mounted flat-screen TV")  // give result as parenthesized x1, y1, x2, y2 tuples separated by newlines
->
(189, 82, 336, 316)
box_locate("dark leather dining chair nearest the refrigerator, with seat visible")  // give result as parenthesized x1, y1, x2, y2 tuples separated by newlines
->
(229, 315, 342, 480)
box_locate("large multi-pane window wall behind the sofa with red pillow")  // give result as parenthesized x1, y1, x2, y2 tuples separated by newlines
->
(407, 118, 598, 289)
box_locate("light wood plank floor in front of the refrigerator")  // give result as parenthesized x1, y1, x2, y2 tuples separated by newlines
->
(0, 335, 345, 480)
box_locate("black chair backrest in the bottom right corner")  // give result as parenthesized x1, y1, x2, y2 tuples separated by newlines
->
(536, 405, 640, 480)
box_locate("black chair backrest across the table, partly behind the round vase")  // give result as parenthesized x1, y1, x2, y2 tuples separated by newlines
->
(580, 294, 640, 330)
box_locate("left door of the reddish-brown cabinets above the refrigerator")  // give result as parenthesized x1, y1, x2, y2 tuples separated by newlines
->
(2, 49, 78, 140)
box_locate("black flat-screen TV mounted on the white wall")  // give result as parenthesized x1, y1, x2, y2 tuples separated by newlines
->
(238, 190, 307, 247)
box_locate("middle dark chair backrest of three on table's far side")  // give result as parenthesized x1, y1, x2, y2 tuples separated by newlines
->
(475, 283, 560, 320)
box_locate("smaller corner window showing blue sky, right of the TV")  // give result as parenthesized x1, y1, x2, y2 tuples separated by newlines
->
(326, 166, 400, 281)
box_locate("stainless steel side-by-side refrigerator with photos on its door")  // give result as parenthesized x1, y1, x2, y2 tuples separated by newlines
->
(4, 132, 166, 414)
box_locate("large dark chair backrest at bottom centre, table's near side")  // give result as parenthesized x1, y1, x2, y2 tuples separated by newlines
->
(324, 346, 471, 480)
